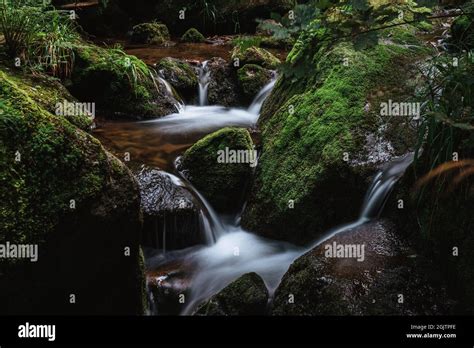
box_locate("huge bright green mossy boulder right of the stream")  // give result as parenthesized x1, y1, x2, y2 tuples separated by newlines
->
(242, 27, 428, 244)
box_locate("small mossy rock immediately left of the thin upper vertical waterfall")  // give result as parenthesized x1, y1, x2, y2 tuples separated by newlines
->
(156, 57, 198, 95)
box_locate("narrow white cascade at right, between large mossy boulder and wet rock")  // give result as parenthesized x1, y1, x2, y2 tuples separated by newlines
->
(311, 153, 414, 249)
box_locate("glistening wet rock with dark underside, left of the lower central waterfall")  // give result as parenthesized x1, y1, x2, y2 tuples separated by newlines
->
(136, 167, 203, 250)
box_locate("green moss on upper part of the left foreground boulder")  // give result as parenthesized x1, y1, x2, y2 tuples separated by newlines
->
(0, 72, 106, 243)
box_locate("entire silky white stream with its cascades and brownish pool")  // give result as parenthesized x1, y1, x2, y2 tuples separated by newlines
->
(93, 67, 413, 315)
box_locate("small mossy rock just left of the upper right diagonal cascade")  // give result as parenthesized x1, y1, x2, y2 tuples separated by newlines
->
(237, 64, 273, 101)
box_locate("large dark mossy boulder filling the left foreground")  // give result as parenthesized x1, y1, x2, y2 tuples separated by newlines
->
(0, 71, 144, 315)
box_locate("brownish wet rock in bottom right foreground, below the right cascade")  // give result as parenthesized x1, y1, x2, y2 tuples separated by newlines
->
(272, 221, 452, 315)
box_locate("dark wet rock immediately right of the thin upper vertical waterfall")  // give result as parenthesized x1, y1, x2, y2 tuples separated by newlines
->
(207, 58, 241, 106)
